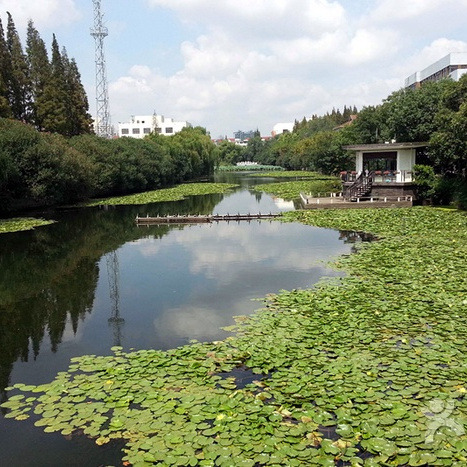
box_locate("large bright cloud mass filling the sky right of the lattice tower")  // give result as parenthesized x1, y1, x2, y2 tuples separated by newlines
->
(107, 0, 467, 136)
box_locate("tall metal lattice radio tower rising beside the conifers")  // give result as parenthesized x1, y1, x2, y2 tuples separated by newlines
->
(91, 0, 112, 138)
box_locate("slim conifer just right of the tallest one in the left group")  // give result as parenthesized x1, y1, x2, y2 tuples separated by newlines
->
(26, 21, 51, 130)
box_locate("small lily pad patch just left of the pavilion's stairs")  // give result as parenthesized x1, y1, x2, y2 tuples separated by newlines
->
(252, 177, 342, 200)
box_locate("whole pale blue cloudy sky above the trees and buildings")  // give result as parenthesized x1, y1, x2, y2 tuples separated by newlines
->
(0, 0, 467, 138)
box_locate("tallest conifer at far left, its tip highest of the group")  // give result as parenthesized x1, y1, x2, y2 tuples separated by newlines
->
(6, 12, 32, 123)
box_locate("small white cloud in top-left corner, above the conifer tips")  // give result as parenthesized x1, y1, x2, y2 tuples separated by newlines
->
(0, 0, 81, 31)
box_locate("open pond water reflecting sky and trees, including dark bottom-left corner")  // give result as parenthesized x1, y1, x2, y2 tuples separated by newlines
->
(0, 175, 366, 467)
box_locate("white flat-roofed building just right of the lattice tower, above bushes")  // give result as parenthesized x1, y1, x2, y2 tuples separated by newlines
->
(118, 114, 191, 138)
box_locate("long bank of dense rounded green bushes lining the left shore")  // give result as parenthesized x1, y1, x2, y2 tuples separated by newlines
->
(0, 119, 221, 210)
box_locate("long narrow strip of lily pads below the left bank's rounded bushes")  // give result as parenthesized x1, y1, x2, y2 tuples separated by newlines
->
(87, 183, 238, 206)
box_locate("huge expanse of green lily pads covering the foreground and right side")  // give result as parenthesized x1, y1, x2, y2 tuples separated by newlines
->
(2, 208, 467, 466)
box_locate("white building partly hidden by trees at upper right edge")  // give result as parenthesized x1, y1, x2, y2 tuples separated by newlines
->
(405, 52, 467, 88)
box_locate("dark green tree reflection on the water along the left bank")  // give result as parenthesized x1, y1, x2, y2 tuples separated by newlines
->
(0, 194, 223, 401)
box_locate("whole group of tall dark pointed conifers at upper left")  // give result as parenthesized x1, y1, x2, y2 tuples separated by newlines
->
(0, 13, 92, 136)
